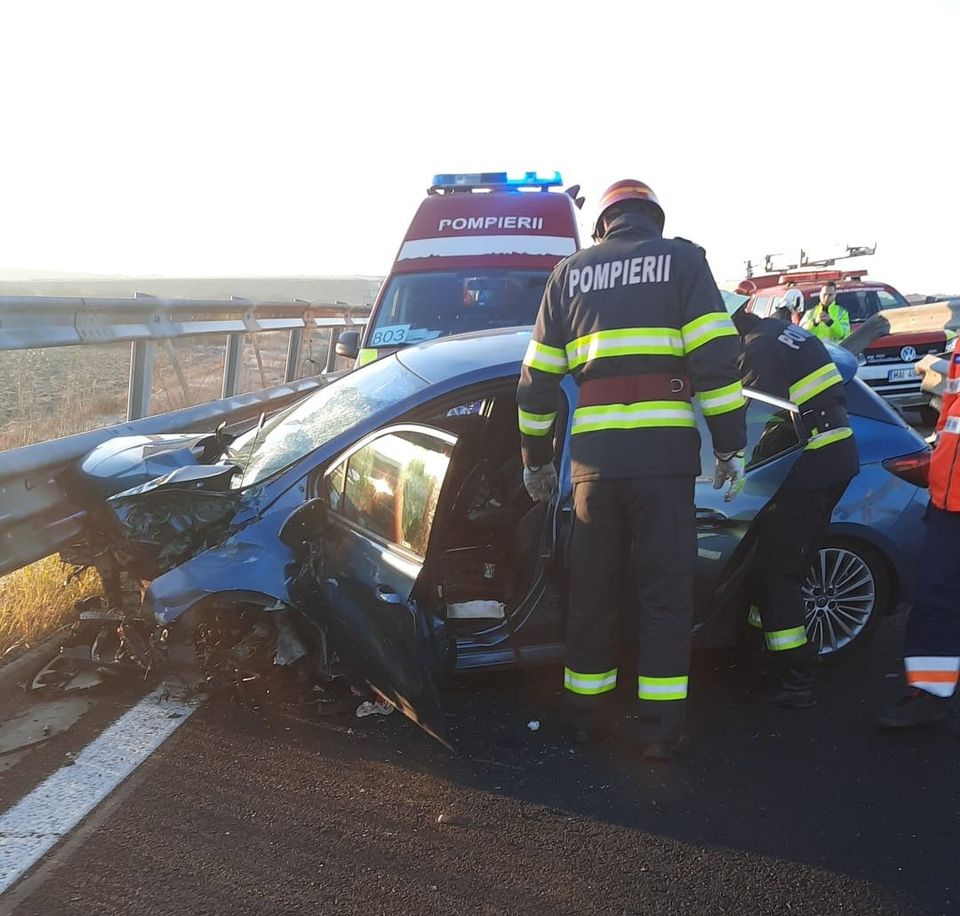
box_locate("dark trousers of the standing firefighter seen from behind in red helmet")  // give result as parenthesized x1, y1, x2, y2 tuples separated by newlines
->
(564, 477, 697, 740)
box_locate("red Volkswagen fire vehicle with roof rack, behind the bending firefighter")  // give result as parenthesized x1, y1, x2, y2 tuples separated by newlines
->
(736, 245, 948, 409)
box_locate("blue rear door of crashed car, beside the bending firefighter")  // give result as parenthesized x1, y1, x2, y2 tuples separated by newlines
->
(694, 389, 807, 646)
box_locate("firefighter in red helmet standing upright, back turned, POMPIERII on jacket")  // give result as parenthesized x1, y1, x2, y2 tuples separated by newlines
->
(517, 179, 746, 759)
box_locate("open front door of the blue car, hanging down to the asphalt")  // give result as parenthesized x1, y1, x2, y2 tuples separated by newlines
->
(288, 424, 457, 747)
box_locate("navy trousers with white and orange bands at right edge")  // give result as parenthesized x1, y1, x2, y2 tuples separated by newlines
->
(903, 506, 960, 696)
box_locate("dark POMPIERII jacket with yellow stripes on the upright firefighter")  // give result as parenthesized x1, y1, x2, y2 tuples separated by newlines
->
(517, 213, 746, 481)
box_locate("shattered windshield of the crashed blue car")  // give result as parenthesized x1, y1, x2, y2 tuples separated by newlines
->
(226, 359, 427, 488)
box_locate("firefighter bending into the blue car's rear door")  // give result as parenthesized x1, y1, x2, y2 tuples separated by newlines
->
(734, 309, 860, 708)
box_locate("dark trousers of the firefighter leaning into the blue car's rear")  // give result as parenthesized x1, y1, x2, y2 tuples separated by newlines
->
(753, 481, 849, 666)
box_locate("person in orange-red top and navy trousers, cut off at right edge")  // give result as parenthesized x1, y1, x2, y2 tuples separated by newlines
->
(880, 344, 960, 729)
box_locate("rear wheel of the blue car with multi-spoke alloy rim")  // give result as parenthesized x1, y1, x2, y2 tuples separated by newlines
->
(803, 539, 890, 663)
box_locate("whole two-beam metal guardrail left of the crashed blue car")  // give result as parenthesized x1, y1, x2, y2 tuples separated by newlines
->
(0, 296, 369, 575)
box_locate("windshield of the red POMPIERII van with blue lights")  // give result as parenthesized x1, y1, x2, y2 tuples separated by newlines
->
(367, 269, 550, 347)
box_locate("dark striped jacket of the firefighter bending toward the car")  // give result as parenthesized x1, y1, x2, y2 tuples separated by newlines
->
(740, 318, 860, 490)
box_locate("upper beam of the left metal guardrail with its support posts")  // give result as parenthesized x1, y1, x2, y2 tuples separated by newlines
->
(0, 294, 370, 420)
